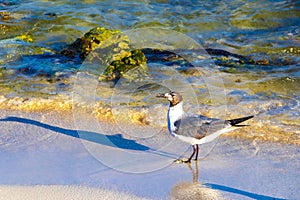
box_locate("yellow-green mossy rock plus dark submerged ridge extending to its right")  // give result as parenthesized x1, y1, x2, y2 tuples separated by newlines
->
(60, 27, 293, 82)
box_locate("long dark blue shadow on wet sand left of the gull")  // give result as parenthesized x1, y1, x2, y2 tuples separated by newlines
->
(0, 117, 150, 151)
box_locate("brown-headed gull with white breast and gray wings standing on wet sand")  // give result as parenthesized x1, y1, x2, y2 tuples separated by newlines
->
(155, 91, 254, 163)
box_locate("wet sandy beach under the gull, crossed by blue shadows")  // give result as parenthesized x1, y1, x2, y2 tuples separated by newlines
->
(0, 110, 300, 199)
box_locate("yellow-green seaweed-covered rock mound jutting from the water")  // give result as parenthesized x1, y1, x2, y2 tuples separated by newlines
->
(61, 27, 147, 81)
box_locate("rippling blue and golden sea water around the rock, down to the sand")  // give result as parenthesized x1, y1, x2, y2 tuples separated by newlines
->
(0, 0, 300, 144)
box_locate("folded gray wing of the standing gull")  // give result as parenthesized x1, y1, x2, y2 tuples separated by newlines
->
(174, 115, 228, 139)
